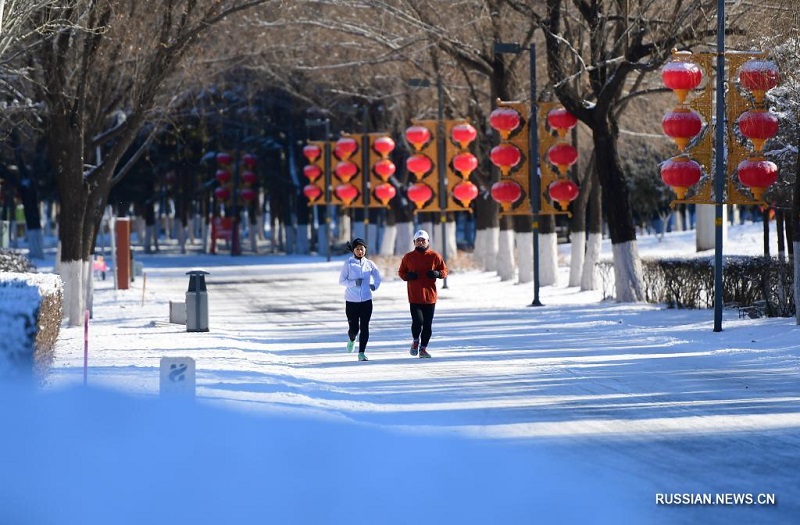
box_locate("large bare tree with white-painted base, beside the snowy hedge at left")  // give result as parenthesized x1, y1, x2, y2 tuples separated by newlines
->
(22, 0, 280, 326)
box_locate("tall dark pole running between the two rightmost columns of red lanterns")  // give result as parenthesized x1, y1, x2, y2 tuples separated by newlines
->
(714, 0, 727, 332)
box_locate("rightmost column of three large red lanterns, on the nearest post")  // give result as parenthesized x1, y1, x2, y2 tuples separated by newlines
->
(736, 59, 780, 200)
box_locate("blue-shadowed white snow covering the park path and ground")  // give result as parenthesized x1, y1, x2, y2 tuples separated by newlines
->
(0, 224, 800, 524)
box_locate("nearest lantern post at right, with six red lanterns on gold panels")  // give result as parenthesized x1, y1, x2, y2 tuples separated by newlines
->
(661, 5, 780, 332)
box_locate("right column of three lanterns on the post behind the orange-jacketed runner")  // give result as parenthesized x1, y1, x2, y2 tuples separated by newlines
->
(446, 121, 478, 210)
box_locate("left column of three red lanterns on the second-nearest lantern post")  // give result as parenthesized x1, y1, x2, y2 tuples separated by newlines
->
(489, 102, 530, 214)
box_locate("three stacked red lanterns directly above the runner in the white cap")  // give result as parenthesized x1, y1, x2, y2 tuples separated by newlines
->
(405, 121, 439, 211)
